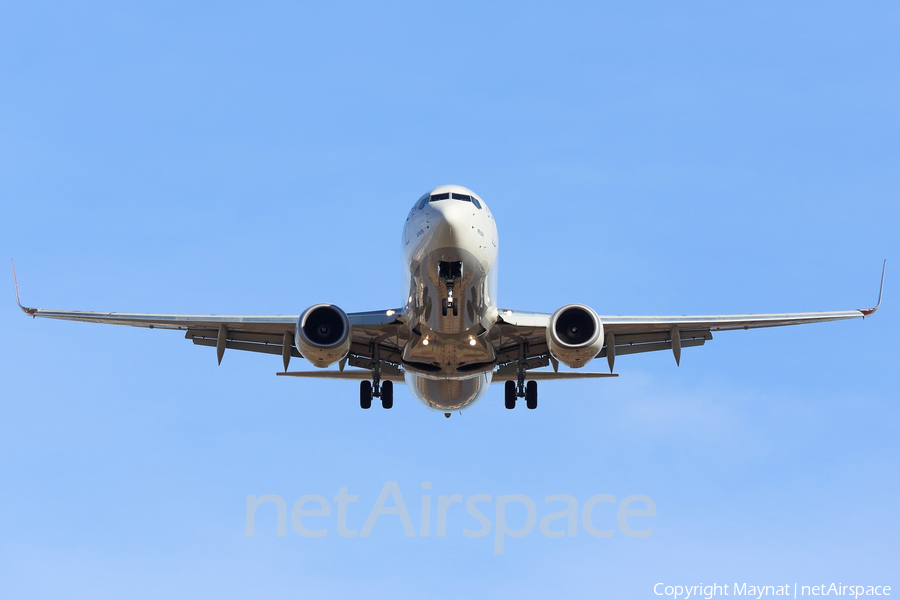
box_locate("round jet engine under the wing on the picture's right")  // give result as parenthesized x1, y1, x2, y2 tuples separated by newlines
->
(547, 304, 603, 369)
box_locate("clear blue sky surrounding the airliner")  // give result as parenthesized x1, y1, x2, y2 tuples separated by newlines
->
(0, 2, 900, 599)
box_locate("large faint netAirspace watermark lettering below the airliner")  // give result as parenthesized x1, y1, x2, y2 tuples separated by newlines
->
(244, 481, 656, 554)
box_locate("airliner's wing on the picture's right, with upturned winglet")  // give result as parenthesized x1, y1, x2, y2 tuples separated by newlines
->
(488, 261, 886, 377)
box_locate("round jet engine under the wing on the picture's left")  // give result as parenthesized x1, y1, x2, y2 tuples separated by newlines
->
(294, 304, 351, 368)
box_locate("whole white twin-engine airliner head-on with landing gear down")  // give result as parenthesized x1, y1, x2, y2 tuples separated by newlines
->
(13, 185, 886, 417)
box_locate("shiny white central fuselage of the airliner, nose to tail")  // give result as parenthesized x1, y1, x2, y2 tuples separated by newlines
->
(401, 185, 498, 412)
